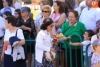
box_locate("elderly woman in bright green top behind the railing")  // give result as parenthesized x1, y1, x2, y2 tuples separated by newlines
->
(61, 10, 86, 67)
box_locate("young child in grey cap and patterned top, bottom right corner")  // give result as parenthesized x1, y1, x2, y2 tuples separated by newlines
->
(91, 39, 100, 67)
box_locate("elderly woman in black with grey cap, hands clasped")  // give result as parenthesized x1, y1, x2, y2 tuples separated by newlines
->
(18, 7, 36, 67)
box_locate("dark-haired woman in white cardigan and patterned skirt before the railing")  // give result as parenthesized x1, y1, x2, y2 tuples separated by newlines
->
(35, 18, 55, 67)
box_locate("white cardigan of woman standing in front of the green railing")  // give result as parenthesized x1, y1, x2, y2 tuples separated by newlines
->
(35, 30, 52, 63)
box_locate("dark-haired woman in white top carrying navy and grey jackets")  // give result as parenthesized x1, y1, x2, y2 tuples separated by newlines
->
(1, 16, 26, 67)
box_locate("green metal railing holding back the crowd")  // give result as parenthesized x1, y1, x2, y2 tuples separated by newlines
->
(26, 34, 90, 67)
